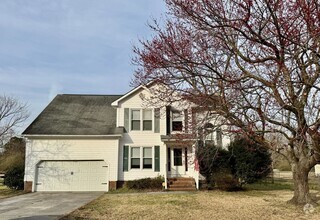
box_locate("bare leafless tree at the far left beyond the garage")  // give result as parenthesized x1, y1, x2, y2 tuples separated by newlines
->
(0, 95, 29, 147)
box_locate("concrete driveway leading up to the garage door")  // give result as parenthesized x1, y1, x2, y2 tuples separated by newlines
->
(0, 192, 103, 220)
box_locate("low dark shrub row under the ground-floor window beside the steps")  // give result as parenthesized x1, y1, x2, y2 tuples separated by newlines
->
(125, 176, 164, 190)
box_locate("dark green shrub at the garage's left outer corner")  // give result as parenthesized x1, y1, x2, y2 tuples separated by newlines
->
(4, 164, 24, 190)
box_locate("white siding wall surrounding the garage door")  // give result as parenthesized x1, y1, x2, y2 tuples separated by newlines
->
(24, 139, 119, 190)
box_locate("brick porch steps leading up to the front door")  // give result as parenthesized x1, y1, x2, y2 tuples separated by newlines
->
(168, 177, 196, 191)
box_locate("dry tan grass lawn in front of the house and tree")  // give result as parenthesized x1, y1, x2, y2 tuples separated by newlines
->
(63, 179, 320, 220)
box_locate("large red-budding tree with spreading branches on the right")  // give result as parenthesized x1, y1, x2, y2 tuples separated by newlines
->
(134, 0, 320, 204)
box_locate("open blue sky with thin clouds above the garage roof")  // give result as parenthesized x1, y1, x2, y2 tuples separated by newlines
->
(0, 0, 165, 132)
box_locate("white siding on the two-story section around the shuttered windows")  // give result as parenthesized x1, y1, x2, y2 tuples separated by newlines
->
(117, 85, 226, 181)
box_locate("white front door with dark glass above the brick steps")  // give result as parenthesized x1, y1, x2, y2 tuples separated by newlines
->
(168, 147, 186, 177)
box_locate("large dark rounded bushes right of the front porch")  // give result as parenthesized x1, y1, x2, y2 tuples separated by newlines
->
(197, 138, 271, 191)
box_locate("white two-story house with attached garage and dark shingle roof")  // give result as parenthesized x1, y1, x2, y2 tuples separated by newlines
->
(23, 83, 229, 192)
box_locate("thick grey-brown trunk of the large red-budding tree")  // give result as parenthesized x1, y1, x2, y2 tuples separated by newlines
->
(289, 162, 314, 205)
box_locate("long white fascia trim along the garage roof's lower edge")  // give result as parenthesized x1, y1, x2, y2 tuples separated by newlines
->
(22, 134, 122, 139)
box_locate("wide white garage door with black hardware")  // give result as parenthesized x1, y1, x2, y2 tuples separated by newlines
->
(35, 161, 108, 191)
